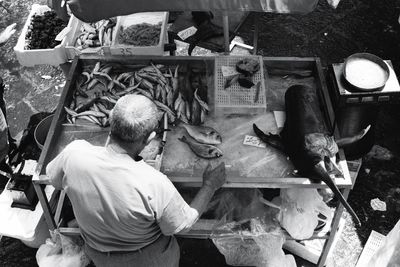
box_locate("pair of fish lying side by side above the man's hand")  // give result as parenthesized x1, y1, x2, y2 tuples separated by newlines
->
(178, 124, 223, 159)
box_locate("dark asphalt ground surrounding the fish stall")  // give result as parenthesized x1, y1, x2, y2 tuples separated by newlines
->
(0, 0, 400, 267)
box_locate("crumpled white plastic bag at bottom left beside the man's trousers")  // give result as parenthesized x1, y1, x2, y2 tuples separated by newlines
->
(36, 232, 90, 267)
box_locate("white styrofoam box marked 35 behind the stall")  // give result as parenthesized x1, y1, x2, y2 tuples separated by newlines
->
(110, 12, 169, 55)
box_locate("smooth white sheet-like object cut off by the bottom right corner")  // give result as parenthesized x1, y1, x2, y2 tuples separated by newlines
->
(366, 220, 400, 267)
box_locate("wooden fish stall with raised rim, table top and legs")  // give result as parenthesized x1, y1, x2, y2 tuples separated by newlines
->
(33, 56, 355, 266)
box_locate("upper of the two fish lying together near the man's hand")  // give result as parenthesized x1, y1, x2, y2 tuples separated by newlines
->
(182, 124, 222, 145)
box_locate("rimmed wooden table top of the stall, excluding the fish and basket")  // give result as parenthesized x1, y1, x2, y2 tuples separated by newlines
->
(33, 57, 352, 192)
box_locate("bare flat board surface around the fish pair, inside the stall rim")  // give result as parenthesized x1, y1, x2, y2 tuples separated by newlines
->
(161, 112, 293, 179)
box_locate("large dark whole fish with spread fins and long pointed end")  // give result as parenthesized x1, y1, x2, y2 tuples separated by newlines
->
(253, 85, 369, 224)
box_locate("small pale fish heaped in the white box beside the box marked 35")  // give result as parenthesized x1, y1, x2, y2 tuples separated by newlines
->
(74, 18, 116, 50)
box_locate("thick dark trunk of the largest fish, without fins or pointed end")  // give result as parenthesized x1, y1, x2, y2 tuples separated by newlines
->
(280, 85, 339, 174)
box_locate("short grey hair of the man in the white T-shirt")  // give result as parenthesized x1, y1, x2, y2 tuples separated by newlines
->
(110, 95, 158, 142)
